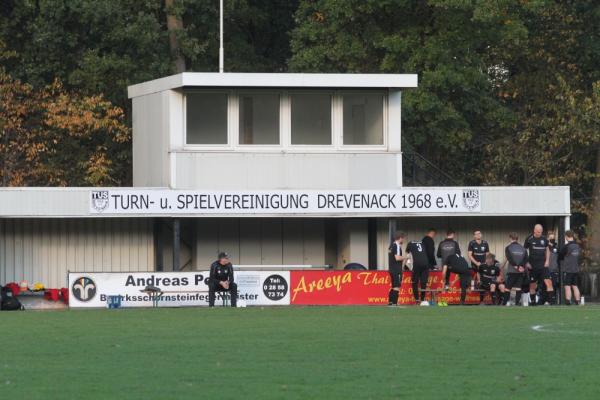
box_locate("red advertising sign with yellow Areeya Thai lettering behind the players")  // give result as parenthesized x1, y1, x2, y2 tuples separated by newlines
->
(290, 271, 489, 305)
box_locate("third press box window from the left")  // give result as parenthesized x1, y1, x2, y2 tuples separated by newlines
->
(291, 93, 331, 145)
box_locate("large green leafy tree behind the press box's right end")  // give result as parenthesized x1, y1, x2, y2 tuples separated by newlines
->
(290, 0, 526, 184)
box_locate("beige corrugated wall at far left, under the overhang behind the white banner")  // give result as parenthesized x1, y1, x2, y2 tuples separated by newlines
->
(0, 218, 154, 288)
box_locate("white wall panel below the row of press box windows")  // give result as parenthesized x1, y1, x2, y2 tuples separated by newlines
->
(174, 152, 402, 190)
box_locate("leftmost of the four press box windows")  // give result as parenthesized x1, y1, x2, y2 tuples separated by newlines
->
(185, 93, 227, 144)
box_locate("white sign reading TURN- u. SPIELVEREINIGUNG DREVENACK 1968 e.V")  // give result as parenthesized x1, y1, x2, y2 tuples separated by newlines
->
(90, 188, 481, 215)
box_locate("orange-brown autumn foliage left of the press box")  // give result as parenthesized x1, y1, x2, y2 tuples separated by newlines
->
(0, 70, 131, 186)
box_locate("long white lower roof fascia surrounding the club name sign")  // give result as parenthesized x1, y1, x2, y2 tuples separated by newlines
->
(0, 186, 571, 218)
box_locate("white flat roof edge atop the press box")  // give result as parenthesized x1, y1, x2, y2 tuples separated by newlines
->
(127, 72, 418, 99)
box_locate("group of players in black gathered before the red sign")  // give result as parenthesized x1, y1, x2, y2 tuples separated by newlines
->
(388, 224, 581, 306)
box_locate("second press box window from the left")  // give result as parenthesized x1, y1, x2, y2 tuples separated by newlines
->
(239, 93, 279, 144)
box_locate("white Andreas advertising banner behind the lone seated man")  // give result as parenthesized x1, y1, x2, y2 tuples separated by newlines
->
(69, 271, 290, 308)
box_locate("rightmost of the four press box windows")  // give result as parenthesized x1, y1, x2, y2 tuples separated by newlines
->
(343, 93, 383, 145)
